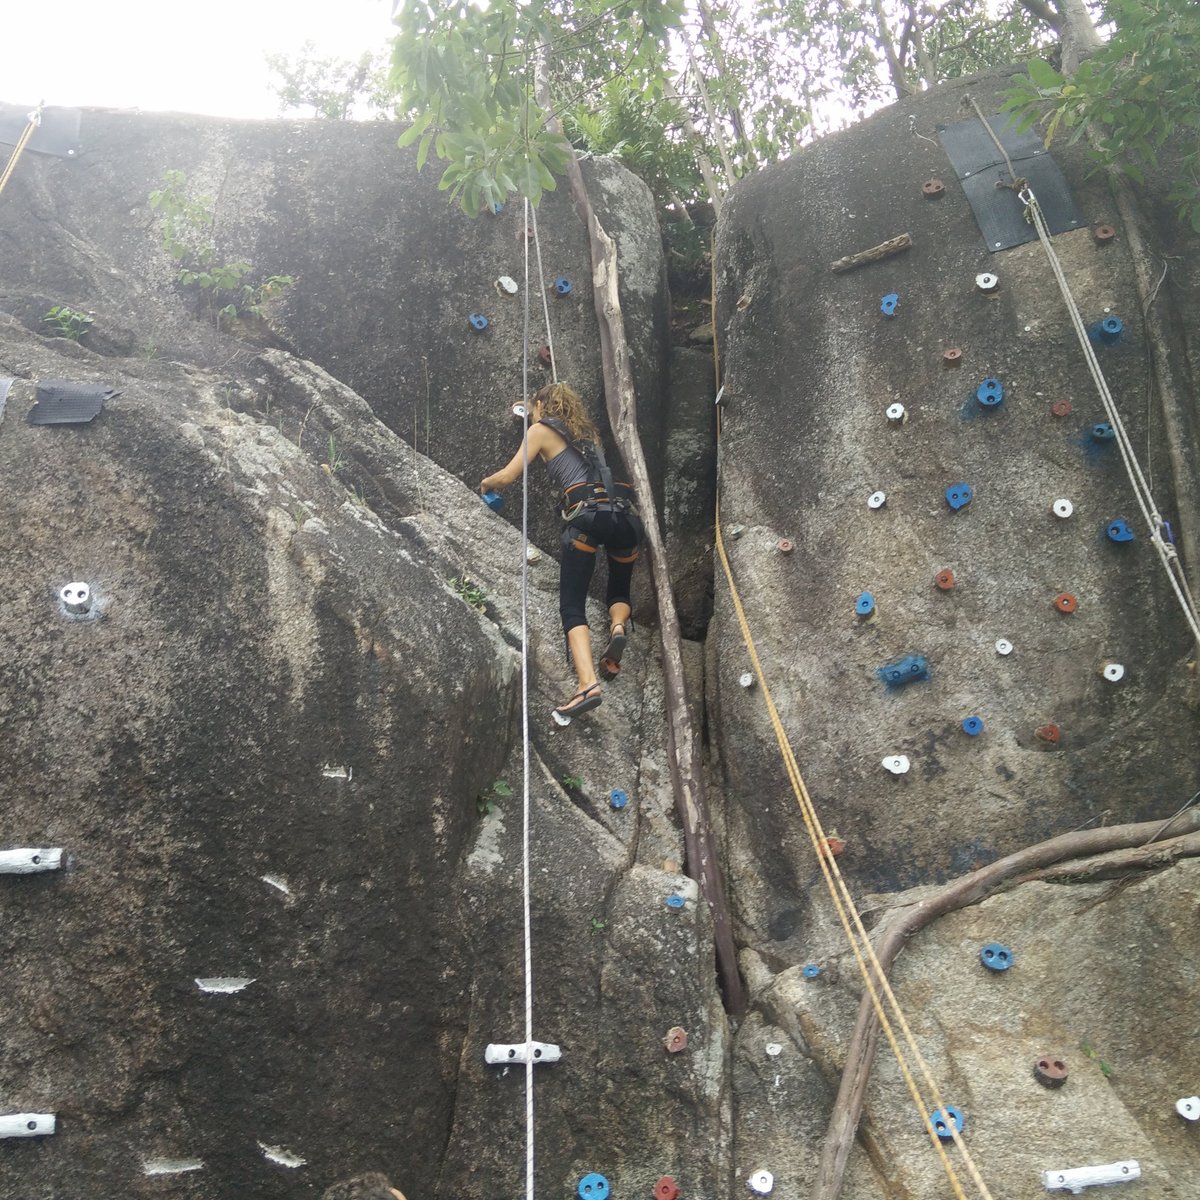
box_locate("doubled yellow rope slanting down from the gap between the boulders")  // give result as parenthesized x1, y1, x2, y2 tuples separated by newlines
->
(712, 248, 991, 1200)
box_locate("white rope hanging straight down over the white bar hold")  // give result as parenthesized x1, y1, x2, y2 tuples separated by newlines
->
(521, 197, 535, 1200)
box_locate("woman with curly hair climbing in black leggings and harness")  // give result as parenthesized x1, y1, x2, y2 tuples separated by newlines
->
(479, 383, 643, 725)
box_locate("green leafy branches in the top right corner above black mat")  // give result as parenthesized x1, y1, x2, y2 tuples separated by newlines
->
(1006, 0, 1200, 233)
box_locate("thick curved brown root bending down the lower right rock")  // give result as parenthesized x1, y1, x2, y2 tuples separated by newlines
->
(811, 809, 1200, 1200)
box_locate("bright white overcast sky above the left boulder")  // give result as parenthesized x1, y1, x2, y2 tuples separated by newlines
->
(0, 0, 392, 116)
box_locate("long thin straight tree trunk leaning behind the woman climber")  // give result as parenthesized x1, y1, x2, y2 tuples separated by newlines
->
(538, 63, 745, 1016)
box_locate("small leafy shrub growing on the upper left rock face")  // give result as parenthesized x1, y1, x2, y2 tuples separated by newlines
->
(150, 170, 295, 329)
